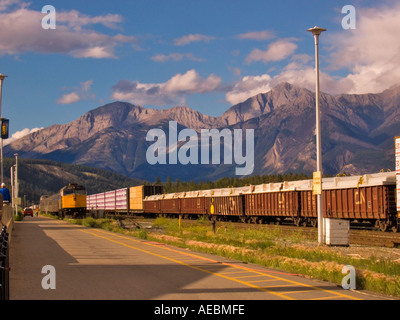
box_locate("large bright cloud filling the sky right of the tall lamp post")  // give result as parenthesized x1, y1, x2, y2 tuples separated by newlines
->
(326, 3, 400, 93)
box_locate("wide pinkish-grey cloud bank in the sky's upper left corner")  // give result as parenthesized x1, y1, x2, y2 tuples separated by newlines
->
(0, 0, 136, 59)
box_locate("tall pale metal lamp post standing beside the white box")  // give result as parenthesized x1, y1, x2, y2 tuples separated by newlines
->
(307, 26, 326, 244)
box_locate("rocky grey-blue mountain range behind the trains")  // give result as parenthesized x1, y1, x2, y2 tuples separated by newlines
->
(4, 83, 400, 181)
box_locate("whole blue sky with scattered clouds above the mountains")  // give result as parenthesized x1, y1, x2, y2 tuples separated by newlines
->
(0, 0, 400, 141)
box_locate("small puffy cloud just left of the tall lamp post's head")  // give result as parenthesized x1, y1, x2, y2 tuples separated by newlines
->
(246, 40, 297, 63)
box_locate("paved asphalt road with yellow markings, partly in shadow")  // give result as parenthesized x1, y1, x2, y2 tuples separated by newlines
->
(10, 216, 394, 307)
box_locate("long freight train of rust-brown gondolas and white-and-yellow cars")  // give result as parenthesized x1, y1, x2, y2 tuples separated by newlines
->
(83, 172, 399, 232)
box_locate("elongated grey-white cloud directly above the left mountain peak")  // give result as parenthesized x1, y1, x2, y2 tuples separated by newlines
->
(112, 69, 222, 105)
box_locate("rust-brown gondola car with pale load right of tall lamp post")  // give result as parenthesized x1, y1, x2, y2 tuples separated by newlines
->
(322, 172, 399, 232)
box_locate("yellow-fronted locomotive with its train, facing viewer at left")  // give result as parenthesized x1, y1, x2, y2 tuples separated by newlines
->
(40, 183, 86, 217)
